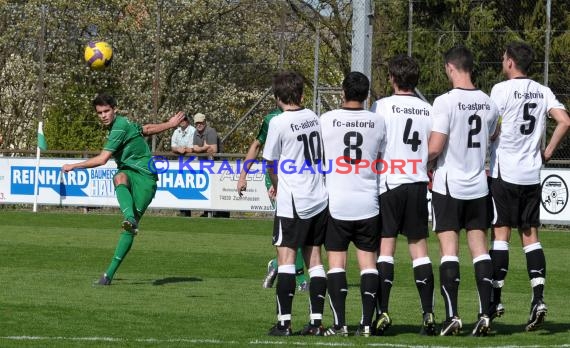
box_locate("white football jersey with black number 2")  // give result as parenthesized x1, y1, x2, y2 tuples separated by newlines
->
(432, 88, 499, 199)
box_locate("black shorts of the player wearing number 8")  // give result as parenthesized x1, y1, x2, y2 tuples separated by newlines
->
(325, 214, 380, 252)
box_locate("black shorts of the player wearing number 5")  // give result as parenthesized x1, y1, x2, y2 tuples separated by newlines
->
(491, 178, 542, 229)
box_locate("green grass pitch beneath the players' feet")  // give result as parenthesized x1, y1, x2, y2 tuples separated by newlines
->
(0, 210, 570, 347)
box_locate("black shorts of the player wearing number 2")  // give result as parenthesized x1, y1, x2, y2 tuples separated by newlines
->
(431, 192, 491, 232)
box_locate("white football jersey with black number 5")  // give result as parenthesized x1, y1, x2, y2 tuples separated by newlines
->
(491, 78, 564, 185)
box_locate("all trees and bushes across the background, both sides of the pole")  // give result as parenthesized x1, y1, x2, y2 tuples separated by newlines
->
(0, 0, 570, 152)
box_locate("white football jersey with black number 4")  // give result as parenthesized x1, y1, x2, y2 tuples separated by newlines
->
(371, 94, 432, 194)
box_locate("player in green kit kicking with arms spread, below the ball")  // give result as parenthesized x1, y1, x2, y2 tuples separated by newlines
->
(62, 93, 184, 285)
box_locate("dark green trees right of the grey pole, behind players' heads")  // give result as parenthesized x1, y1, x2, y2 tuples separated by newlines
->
(372, 0, 570, 101)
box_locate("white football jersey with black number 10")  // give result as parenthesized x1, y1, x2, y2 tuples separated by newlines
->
(263, 109, 328, 219)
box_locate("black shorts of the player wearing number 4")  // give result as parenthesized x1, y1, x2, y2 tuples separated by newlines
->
(380, 182, 429, 240)
